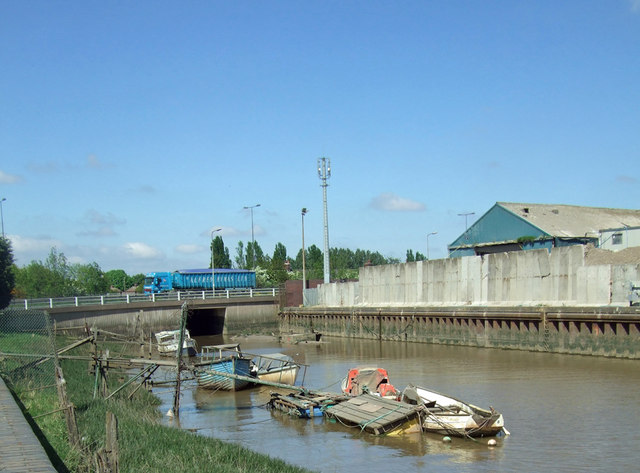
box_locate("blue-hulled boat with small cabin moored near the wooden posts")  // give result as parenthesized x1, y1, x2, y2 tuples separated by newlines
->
(193, 344, 252, 391)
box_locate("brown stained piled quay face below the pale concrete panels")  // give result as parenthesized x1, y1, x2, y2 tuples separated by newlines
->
(280, 307, 640, 359)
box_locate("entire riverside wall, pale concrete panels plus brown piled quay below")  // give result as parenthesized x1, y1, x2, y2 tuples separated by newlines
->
(280, 246, 640, 359)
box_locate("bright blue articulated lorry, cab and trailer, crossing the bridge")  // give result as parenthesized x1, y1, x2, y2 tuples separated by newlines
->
(144, 268, 256, 294)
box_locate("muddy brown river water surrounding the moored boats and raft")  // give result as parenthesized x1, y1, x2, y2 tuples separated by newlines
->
(152, 338, 640, 473)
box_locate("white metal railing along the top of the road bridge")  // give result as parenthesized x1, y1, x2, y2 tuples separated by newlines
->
(8, 287, 279, 309)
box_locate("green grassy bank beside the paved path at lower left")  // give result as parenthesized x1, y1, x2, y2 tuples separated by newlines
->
(5, 334, 309, 473)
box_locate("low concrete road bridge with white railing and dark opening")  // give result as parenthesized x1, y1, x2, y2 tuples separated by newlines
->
(8, 288, 280, 335)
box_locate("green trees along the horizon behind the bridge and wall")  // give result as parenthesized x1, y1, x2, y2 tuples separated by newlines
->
(0, 236, 425, 309)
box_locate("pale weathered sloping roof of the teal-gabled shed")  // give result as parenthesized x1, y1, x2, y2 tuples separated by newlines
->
(497, 202, 640, 237)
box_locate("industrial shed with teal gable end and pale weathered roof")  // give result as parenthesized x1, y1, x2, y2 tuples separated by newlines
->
(448, 202, 640, 257)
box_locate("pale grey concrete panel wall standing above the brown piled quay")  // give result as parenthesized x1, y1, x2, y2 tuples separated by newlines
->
(317, 245, 640, 307)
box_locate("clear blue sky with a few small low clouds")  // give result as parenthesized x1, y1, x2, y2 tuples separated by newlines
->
(0, 0, 640, 274)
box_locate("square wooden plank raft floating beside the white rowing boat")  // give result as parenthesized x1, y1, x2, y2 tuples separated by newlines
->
(325, 394, 423, 435)
